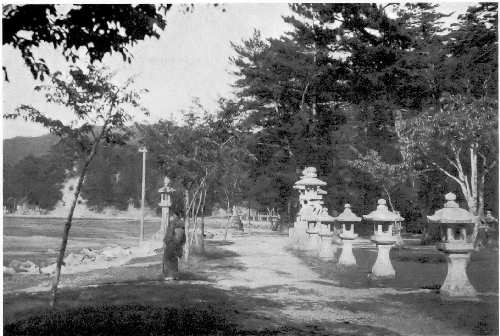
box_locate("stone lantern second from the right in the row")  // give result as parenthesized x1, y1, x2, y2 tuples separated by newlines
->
(363, 199, 404, 278)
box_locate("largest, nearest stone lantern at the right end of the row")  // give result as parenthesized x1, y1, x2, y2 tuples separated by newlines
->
(427, 193, 478, 300)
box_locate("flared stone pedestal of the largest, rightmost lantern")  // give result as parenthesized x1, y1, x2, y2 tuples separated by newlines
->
(438, 243, 478, 301)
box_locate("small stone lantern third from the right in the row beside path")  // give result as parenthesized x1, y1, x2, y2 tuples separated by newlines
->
(335, 204, 361, 266)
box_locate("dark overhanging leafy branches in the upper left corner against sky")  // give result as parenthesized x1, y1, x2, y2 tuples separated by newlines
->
(2, 4, 171, 80)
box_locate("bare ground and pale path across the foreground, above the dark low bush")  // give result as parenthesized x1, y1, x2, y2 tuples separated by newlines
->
(4, 232, 498, 335)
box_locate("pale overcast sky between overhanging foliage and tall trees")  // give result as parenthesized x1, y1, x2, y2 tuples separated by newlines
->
(2, 2, 471, 138)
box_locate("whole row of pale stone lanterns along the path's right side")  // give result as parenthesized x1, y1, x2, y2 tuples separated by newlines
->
(289, 167, 477, 299)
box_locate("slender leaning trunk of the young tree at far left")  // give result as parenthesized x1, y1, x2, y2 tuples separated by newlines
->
(50, 121, 107, 307)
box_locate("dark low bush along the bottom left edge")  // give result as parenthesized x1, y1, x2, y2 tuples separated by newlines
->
(4, 305, 234, 336)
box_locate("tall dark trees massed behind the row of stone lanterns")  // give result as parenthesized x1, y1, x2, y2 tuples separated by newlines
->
(223, 4, 498, 228)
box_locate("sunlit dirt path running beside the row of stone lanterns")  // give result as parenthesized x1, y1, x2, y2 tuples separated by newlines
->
(207, 235, 470, 335)
